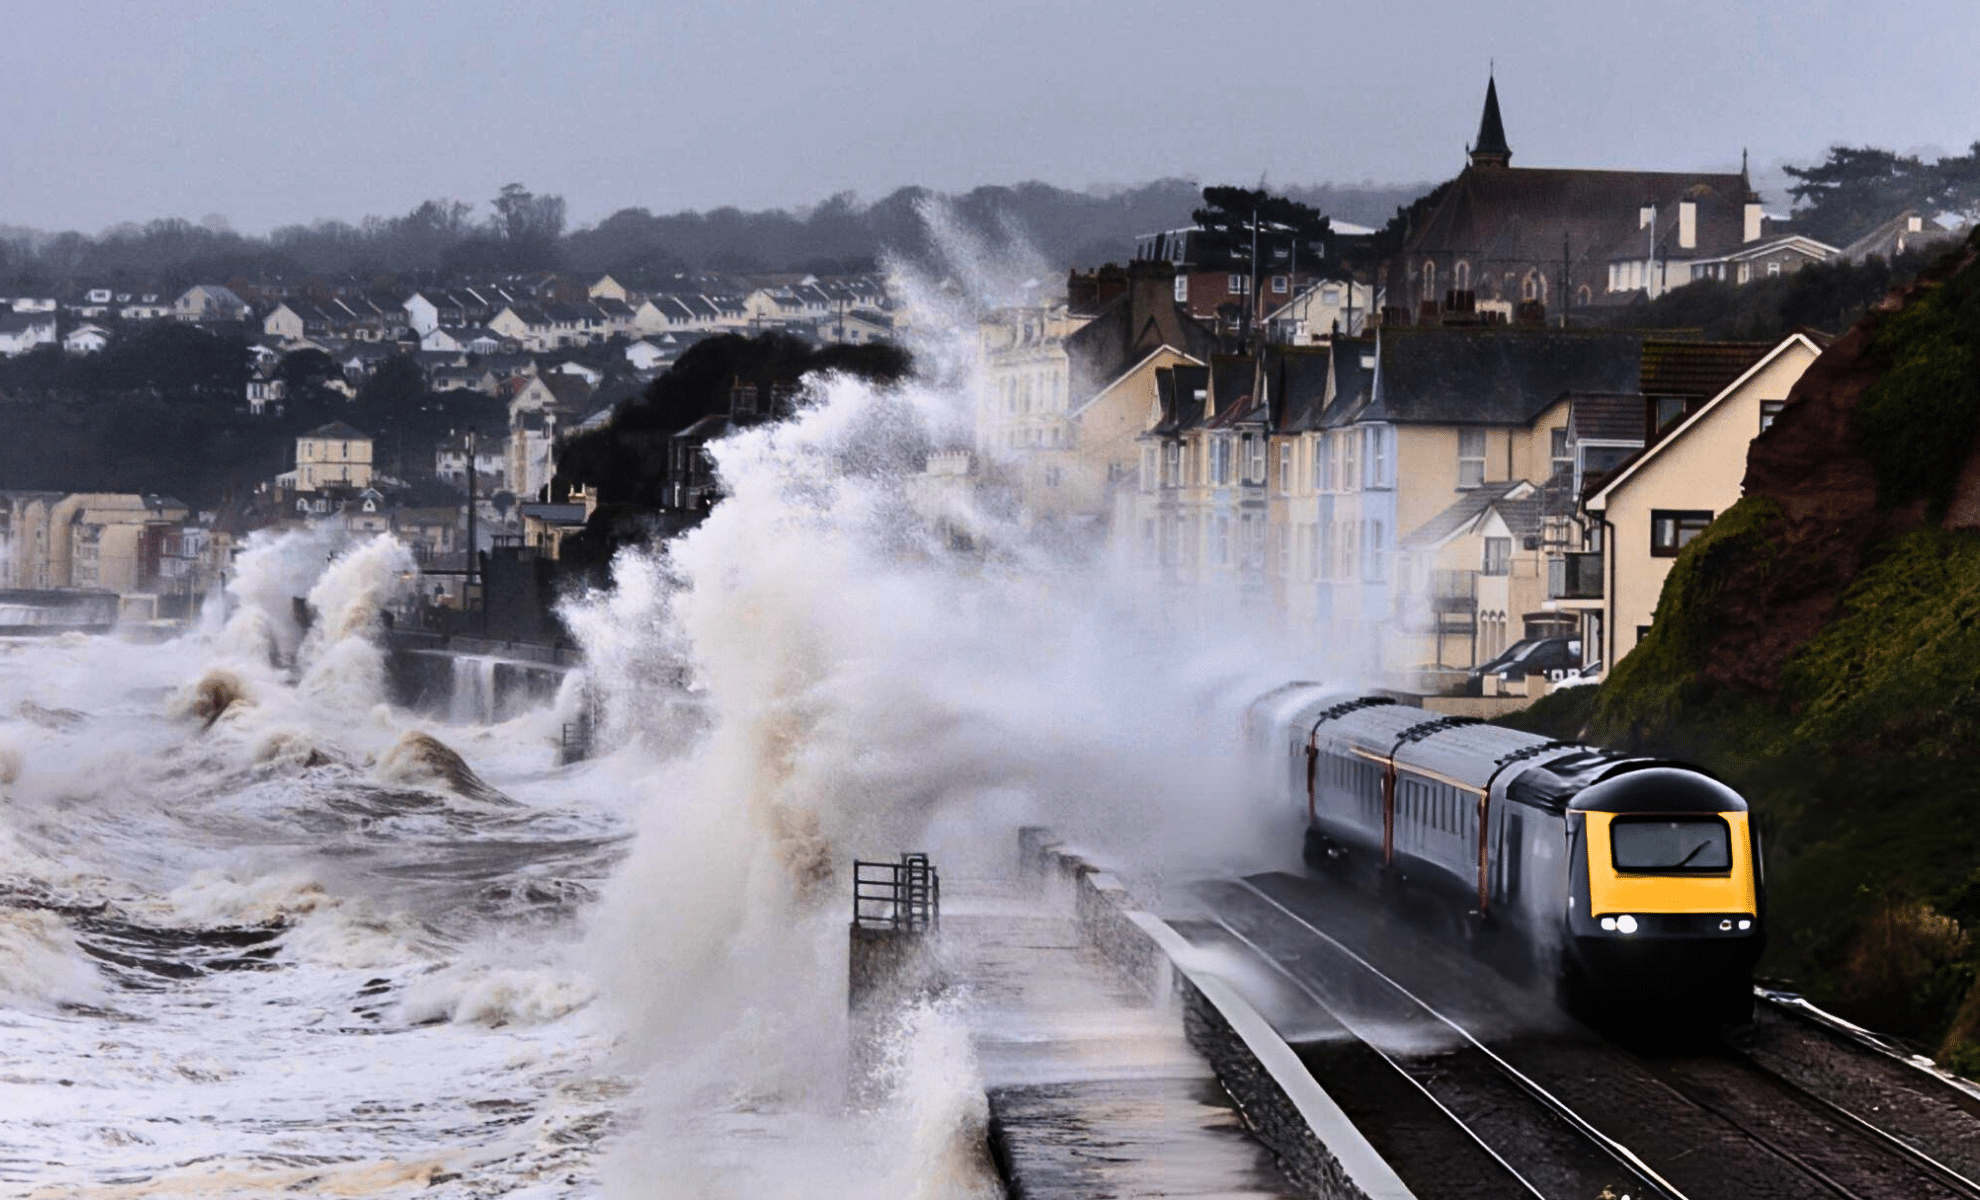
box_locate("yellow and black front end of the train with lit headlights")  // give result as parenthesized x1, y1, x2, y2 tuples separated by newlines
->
(1566, 764, 1762, 1020)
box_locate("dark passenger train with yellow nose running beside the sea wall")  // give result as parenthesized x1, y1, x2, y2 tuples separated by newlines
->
(1243, 683, 1766, 1024)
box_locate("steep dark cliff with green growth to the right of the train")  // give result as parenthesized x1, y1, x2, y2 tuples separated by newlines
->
(1519, 238, 1980, 1069)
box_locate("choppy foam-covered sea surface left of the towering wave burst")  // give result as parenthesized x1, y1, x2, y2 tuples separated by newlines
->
(0, 537, 628, 1196)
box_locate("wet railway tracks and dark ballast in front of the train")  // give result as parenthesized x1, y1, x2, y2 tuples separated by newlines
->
(1178, 875, 1980, 1200)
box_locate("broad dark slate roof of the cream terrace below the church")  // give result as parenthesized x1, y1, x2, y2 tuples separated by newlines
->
(1362, 327, 1643, 426)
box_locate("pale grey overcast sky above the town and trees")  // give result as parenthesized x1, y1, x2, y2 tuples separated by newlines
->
(0, 0, 1980, 232)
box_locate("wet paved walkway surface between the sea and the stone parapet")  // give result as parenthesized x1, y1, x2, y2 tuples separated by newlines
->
(942, 877, 1299, 1200)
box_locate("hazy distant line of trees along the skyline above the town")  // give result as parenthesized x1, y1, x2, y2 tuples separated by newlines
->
(0, 178, 1422, 291)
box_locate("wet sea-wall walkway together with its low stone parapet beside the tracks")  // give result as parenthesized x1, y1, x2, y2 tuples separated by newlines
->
(942, 828, 1410, 1200)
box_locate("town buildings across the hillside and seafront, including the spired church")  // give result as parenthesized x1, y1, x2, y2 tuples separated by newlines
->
(0, 81, 1962, 711)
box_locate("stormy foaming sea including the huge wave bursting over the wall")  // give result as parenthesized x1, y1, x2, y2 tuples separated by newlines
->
(0, 212, 1325, 1200)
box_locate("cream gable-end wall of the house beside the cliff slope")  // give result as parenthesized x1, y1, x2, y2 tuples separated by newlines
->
(1584, 333, 1822, 665)
